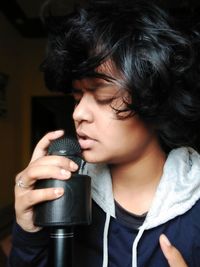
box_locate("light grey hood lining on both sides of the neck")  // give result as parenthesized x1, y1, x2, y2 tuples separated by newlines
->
(83, 147, 200, 229)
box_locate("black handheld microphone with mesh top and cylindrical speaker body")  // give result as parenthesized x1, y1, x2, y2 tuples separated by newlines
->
(34, 137, 91, 267)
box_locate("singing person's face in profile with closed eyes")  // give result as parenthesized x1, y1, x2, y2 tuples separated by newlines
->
(73, 63, 158, 164)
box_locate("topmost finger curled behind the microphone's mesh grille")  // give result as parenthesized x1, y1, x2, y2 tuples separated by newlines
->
(31, 130, 64, 162)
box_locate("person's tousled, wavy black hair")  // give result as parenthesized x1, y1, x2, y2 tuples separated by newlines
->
(42, 0, 200, 152)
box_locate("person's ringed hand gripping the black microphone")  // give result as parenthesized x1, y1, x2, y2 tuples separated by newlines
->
(15, 130, 78, 232)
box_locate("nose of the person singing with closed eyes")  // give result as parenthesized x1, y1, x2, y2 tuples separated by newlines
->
(72, 95, 93, 123)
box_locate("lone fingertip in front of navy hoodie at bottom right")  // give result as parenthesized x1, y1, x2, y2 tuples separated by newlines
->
(159, 234, 188, 267)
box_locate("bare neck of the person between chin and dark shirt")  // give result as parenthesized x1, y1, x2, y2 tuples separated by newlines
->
(110, 142, 166, 214)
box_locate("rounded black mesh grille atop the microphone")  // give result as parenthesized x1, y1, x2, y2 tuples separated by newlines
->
(48, 136, 82, 168)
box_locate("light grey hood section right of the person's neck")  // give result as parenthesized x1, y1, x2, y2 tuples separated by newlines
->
(145, 148, 200, 229)
